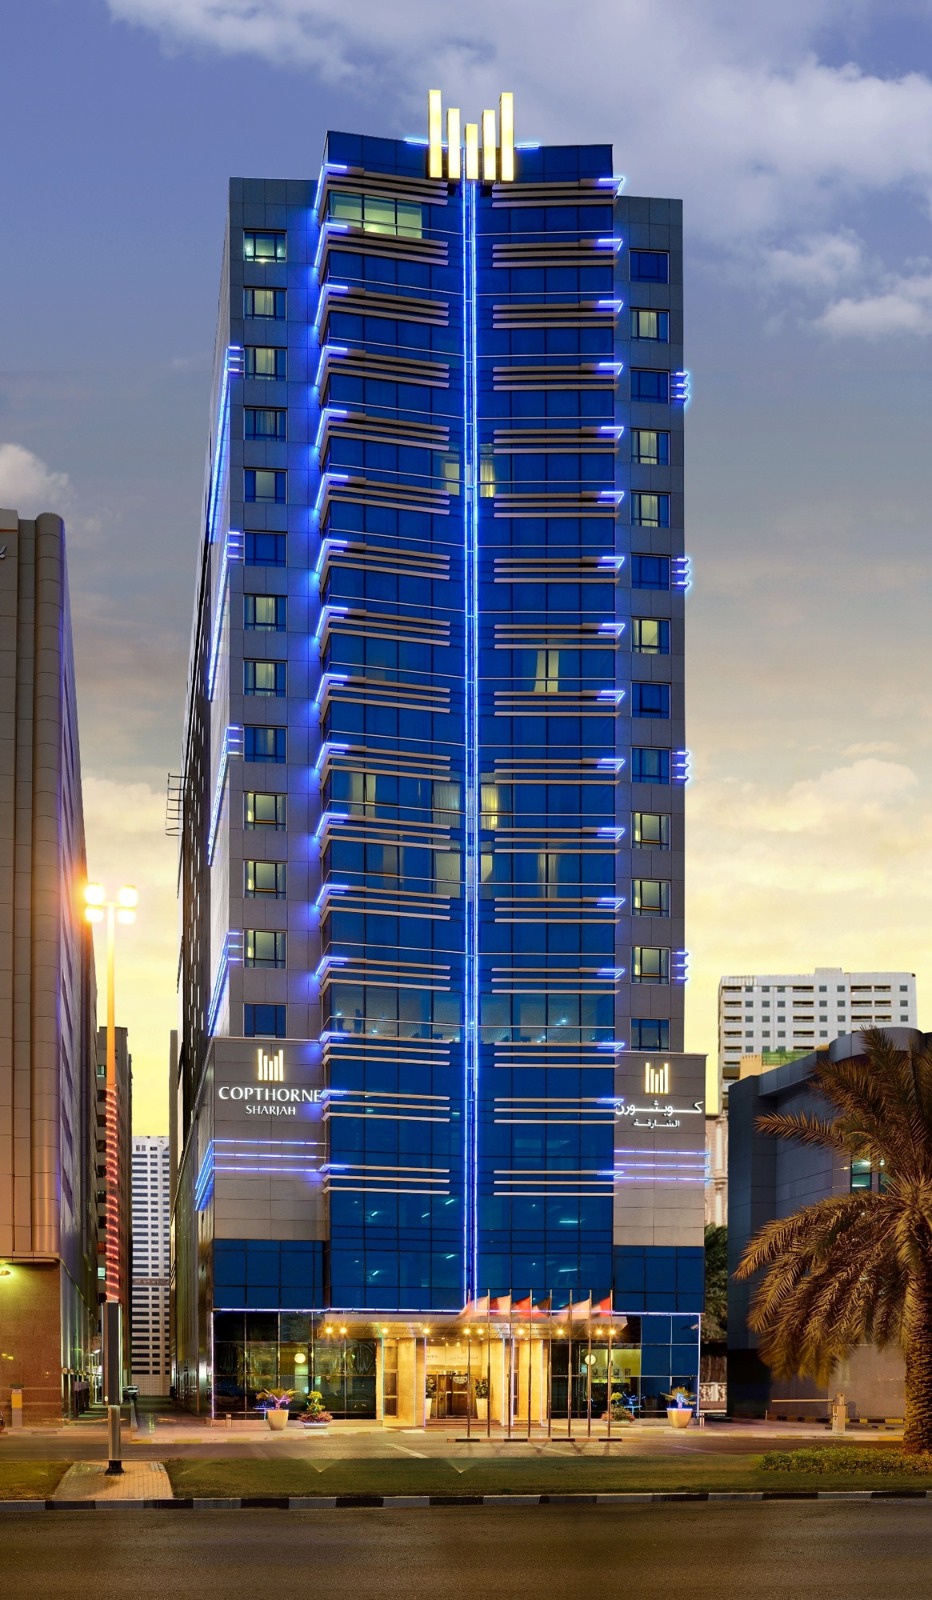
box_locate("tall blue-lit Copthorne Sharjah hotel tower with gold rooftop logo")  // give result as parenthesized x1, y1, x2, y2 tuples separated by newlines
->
(175, 96, 703, 1422)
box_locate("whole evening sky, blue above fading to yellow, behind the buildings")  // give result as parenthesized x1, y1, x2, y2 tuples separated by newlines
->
(0, 0, 932, 1133)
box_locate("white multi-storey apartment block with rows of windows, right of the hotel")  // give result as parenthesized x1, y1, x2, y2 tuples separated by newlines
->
(719, 966, 916, 1094)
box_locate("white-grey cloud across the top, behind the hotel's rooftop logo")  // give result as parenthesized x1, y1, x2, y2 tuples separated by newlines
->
(109, 0, 932, 237)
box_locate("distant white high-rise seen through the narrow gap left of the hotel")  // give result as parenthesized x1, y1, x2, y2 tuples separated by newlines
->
(133, 1136, 171, 1395)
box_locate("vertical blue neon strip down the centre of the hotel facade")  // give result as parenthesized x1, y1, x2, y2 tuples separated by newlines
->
(463, 179, 480, 1302)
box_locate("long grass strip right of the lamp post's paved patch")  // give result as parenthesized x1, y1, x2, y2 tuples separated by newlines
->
(165, 1454, 932, 1499)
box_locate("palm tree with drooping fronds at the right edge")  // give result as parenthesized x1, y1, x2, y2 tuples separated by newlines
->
(735, 1029, 932, 1451)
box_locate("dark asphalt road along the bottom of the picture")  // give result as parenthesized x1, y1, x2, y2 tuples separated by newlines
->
(0, 1501, 932, 1600)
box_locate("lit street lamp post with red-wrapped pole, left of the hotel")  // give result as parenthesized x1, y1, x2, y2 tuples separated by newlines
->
(85, 883, 139, 1475)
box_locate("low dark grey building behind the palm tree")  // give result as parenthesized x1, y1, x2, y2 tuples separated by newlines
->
(729, 1027, 929, 1418)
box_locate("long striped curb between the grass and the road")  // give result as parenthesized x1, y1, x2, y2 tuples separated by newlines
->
(0, 1490, 932, 1515)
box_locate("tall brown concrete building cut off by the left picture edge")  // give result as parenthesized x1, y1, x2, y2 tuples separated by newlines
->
(0, 510, 98, 1422)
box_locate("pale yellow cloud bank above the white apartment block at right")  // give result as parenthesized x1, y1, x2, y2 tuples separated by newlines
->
(687, 757, 932, 1094)
